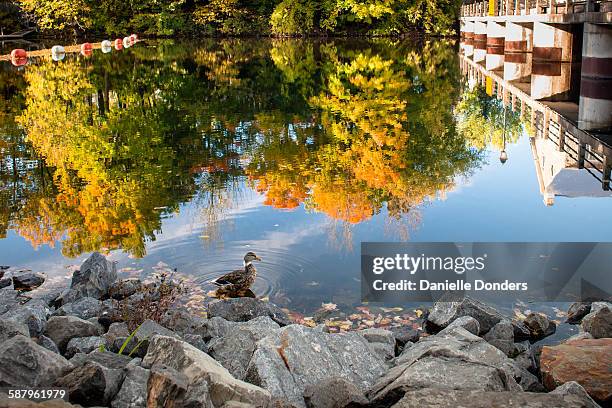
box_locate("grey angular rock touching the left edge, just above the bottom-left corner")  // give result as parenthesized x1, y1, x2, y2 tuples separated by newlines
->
(0, 335, 72, 387)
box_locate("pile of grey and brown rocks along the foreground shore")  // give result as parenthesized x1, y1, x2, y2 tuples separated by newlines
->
(0, 254, 612, 408)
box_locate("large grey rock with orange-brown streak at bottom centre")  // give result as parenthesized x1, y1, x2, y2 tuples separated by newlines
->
(245, 325, 386, 407)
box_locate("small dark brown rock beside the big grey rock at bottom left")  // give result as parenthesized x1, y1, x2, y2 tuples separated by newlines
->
(55, 361, 124, 406)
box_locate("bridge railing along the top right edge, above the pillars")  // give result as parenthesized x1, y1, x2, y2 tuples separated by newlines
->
(461, 0, 612, 17)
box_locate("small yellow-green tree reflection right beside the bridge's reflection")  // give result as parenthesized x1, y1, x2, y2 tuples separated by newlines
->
(456, 86, 522, 149)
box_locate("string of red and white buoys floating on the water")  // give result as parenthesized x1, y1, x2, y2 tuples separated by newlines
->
(0, 34, 138, 67)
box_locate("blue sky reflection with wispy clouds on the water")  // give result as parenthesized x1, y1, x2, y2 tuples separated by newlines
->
(0, 129, 612, 318)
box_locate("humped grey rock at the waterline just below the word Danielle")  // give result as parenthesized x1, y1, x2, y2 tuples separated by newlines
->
(427, 296, 504, 335)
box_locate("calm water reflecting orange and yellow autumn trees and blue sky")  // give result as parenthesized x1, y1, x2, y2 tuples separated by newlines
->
(0, 40, 612, 334)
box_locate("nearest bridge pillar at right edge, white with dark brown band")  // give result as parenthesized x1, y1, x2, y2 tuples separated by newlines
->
(578, 23, 612, 130)
